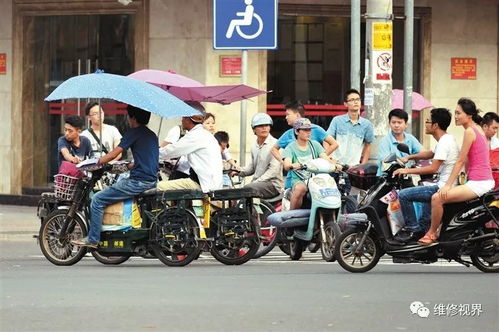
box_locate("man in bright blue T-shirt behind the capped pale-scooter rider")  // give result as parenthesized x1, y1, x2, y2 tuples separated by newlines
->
(271, 101, 338, 189)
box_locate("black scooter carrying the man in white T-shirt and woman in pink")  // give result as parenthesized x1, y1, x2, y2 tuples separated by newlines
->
(335, 144, 499, 273)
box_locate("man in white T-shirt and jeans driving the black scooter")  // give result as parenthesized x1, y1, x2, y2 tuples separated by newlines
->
(393, 108, 459, 242)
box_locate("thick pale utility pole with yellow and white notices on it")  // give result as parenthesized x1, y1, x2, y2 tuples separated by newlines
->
(364, 0, 393, 159)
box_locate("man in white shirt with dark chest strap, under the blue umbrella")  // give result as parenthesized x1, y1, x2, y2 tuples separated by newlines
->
(81, 102, 121, 160)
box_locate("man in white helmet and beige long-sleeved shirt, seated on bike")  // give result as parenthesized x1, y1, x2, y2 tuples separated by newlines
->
(235, 113, 284, 198)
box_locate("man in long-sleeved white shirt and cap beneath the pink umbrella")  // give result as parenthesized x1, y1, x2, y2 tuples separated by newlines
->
(157, 103, 223, 192)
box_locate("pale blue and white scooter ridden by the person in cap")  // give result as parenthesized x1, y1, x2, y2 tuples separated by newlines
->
(268, 158, 343, 262)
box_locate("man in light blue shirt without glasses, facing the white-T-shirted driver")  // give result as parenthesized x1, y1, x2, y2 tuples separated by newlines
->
(376, 108, 422, 176)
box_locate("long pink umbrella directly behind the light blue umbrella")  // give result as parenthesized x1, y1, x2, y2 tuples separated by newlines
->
(128, 69, 267, 105)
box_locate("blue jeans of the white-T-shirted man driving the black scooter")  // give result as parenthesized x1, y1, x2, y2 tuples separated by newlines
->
(399, 186, 438, 232)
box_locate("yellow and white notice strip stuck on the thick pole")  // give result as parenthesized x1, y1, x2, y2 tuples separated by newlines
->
(372, 23, 393, 83)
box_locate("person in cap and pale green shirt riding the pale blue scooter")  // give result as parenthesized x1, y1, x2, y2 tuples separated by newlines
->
(283, 118, 333, 210)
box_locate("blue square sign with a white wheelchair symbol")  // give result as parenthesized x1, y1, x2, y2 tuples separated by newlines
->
(213, 0, 277, 50)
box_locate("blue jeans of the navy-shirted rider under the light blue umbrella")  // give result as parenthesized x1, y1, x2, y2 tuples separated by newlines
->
(88, 178, 156, 243)
